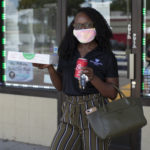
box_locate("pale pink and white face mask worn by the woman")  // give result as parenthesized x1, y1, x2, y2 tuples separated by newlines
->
(73, 28, 96, 43)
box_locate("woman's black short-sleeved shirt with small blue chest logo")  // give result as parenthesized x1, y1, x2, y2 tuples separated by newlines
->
(57, 47, 118, 96)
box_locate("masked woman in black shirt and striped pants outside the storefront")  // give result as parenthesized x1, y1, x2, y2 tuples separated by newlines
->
(35, 8, 118, 150)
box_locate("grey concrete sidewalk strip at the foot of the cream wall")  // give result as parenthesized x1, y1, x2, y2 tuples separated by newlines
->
(0, 139, 50, 150)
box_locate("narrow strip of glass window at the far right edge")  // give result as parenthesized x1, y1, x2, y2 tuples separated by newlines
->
(142, 0, 150, 96)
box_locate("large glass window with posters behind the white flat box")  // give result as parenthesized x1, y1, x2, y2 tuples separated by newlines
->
(4, 0, 57, 89)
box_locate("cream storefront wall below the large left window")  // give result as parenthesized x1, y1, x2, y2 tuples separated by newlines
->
(0, 94, 57, 146)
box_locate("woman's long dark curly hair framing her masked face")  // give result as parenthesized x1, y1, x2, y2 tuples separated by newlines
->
(58, 7, 112, 60)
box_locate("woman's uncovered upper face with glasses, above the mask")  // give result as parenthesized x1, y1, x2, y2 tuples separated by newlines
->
(73, 12, 94, 30)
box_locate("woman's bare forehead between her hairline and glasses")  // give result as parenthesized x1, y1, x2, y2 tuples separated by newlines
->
(74, 12, 92, 23)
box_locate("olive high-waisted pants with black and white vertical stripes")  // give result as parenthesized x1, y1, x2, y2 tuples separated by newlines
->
(50, 94, 109, 150)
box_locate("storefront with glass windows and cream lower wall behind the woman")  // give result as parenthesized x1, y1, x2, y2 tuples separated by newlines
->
(0, 0, 150, 150)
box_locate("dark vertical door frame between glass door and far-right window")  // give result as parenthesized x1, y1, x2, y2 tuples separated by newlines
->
(131, 0, 150, 106)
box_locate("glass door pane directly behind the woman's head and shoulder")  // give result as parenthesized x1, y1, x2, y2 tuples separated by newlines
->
(67, 0, 131, 96)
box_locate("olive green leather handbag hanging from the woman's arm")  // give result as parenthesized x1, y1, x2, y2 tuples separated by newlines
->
(87, 86, 147, 139)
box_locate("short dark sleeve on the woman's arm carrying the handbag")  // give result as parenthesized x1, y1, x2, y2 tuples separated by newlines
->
(105, 53, 118, 78)
